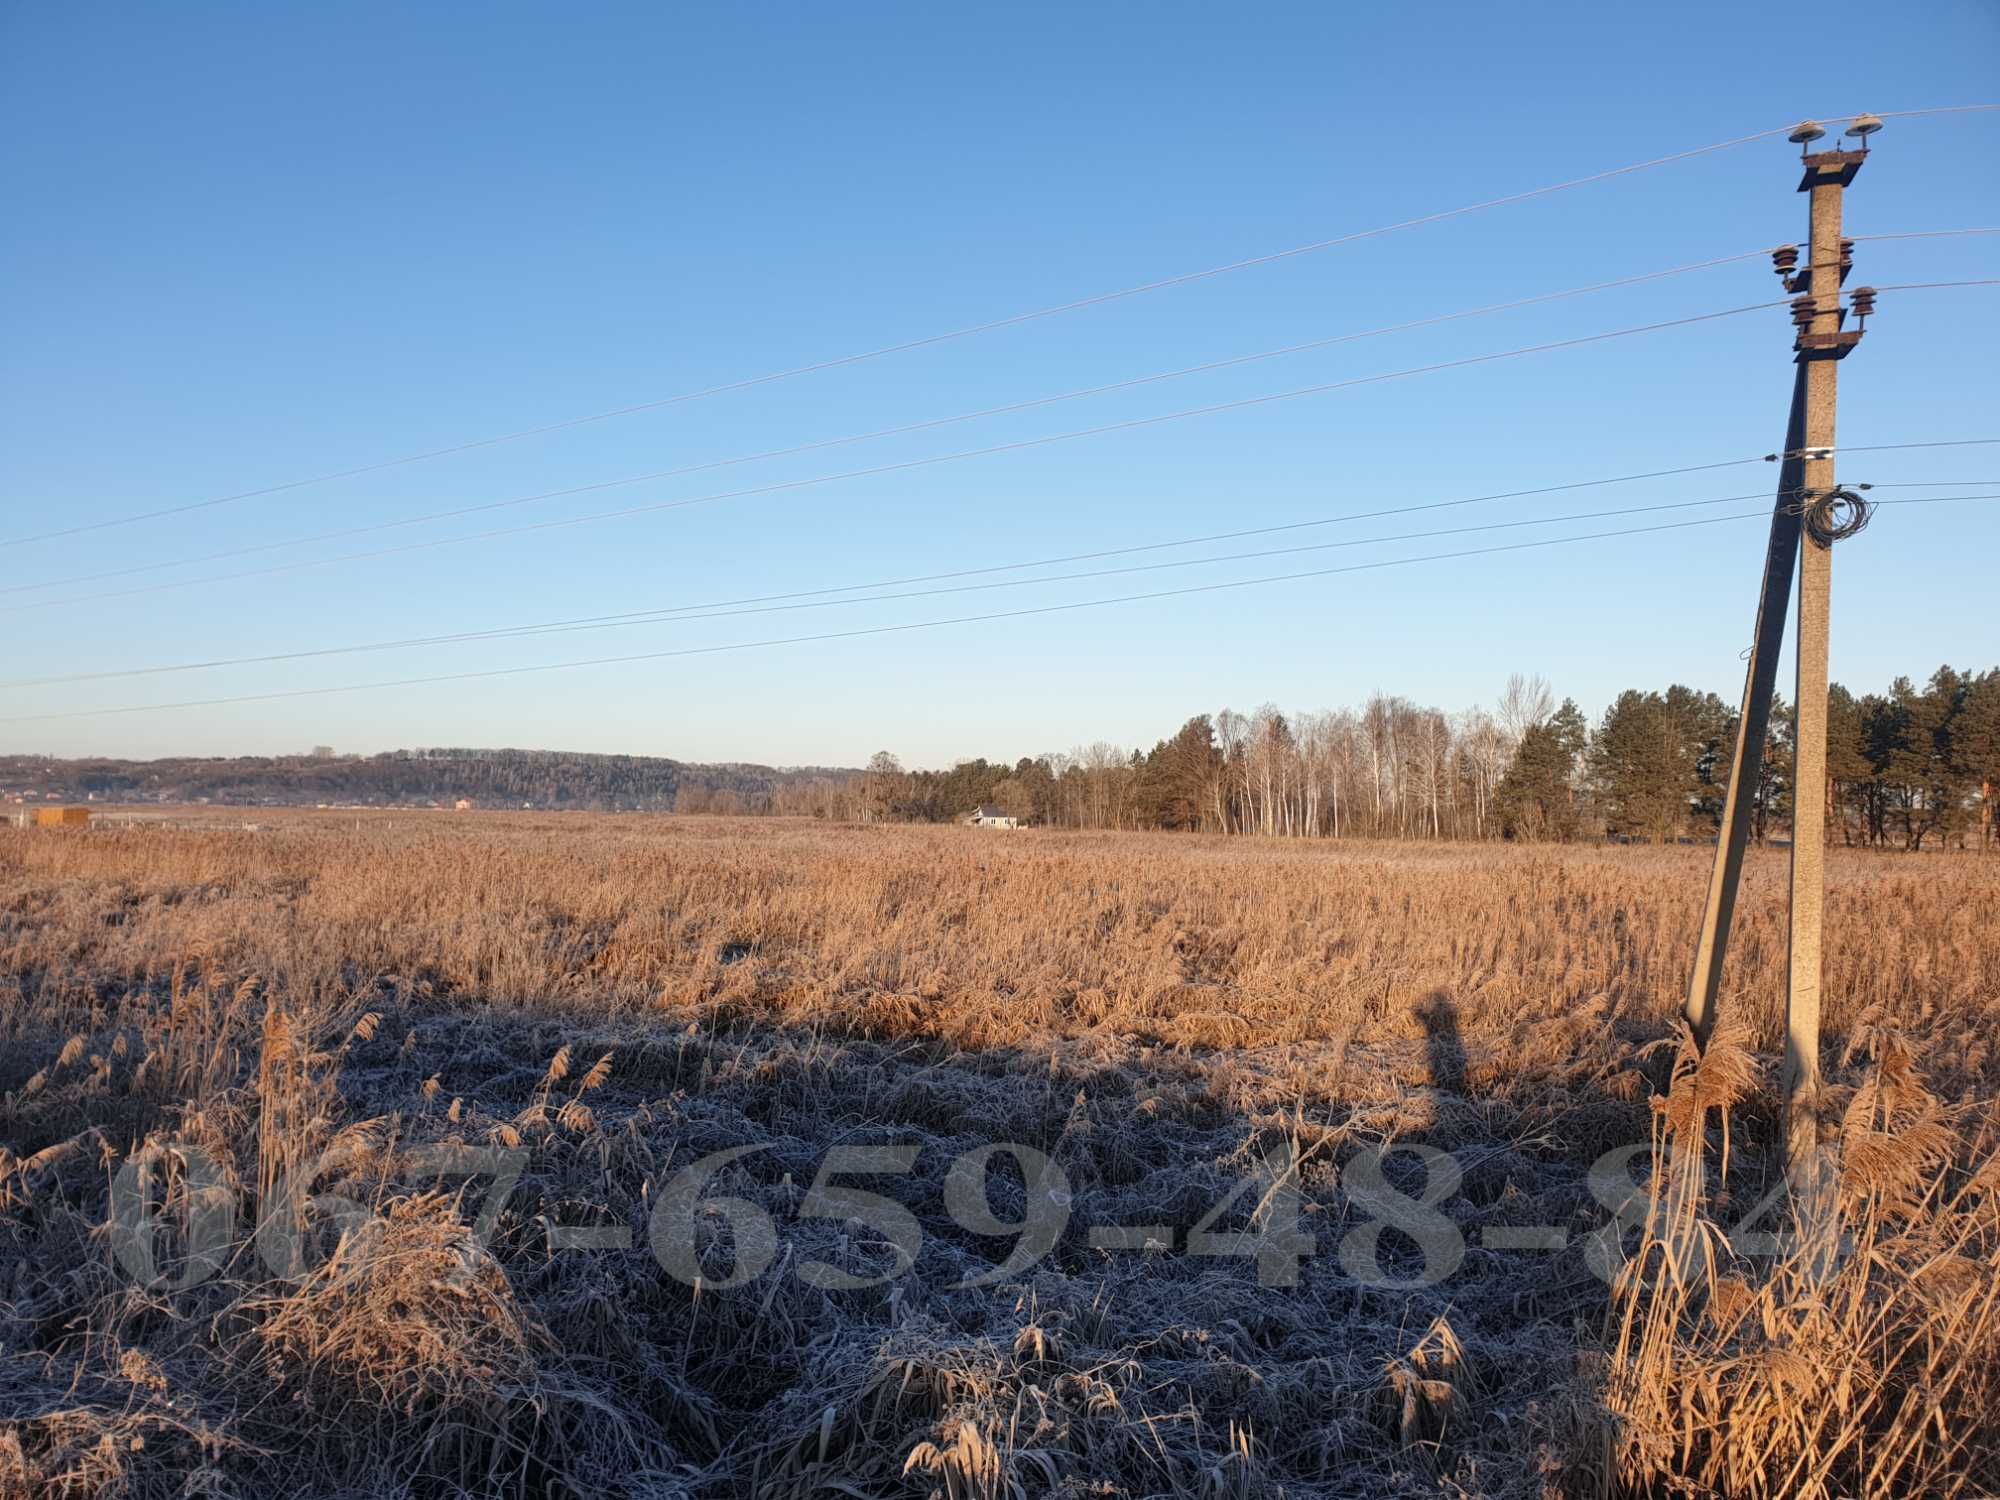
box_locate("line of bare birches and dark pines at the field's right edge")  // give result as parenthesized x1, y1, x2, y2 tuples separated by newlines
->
(848, 668, 2000, 850)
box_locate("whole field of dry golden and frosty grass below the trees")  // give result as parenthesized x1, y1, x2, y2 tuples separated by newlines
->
(0, 814, 2000, 1500)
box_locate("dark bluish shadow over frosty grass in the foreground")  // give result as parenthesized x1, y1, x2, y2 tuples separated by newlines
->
(0, 980, 1640, 1496)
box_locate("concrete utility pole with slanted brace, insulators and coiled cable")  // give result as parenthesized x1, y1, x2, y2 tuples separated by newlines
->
(1686, 114, 1882, 1192)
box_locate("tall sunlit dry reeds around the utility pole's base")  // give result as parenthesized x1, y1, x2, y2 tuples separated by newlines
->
(1600, 1028, 2000, 1500)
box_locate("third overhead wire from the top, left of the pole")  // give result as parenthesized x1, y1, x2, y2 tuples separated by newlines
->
(0, 298, 1790, 614)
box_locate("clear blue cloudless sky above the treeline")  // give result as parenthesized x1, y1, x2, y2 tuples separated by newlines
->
(0, 0, 2000, 764)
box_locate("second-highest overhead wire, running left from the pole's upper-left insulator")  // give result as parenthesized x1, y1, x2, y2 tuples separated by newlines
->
(0, 250, 1770, 594)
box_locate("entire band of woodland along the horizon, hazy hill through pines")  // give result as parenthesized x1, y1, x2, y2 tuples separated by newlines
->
(0, 666, 2000, 850)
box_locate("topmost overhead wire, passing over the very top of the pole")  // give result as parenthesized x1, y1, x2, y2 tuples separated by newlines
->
(0, 104, 2000, 546)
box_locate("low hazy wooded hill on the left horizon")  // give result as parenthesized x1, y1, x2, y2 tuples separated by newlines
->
(0, 750, 858, 812)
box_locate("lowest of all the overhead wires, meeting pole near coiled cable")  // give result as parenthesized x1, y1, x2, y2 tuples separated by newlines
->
(0, 496, 1986, 724)
